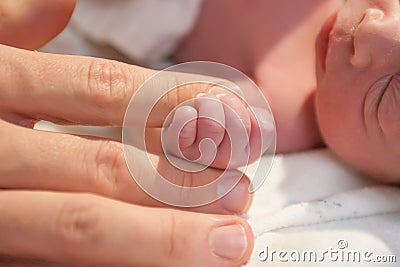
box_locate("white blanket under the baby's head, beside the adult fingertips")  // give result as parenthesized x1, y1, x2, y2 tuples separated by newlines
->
(248, 149, 400, 266)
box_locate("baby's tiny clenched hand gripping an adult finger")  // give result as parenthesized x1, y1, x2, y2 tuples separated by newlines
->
(163, 88, 274, 169)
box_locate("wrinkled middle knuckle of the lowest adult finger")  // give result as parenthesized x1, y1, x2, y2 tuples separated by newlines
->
(54, 195, 105, 250)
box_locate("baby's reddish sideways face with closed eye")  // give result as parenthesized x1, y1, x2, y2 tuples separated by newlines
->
(316, 0, 400, 181)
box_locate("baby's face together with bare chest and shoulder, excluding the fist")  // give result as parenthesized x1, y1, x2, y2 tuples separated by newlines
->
(174, 0, 400, 182)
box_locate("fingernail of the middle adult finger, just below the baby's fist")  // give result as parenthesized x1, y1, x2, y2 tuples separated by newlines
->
(218, 178, 251, 214)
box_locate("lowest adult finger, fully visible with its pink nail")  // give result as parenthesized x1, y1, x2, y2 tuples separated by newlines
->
(0, 191, 253, 267)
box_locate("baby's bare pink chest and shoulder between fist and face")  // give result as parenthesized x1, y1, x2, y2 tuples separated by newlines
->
(173, 0, 342, 153)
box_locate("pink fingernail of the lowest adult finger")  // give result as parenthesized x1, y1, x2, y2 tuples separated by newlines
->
(209, 224, 248, 260)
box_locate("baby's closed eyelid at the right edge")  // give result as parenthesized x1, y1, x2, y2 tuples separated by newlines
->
(378, 74, 400, 140)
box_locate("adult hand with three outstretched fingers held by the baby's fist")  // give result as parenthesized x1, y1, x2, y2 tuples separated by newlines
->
(0, 46, 253, 266)
